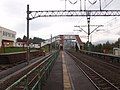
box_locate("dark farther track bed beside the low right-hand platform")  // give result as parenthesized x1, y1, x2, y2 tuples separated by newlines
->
(76, 53, 120, 75)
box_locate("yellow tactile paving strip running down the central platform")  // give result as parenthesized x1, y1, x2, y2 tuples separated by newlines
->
(61, 51, 72, 90)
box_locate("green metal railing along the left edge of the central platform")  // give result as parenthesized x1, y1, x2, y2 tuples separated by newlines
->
(6, 51, 59, 90)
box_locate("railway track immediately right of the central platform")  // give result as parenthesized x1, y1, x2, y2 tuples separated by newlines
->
(67, 52, 120, 90)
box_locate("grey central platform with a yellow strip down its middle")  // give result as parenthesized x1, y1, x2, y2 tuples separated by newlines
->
(42, 51, 97, 90)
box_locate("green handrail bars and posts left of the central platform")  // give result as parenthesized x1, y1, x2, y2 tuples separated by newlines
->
(6, 51, 59, 90)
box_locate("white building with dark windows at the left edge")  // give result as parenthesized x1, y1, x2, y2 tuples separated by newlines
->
(0, 26, 16, 47)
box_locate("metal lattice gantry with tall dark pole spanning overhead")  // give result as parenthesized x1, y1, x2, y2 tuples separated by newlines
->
(27, 5, 120, 63)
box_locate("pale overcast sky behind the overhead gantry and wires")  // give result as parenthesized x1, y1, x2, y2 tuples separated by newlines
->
(0, 0, 120, 42)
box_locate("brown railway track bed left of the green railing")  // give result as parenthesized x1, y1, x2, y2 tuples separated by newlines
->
(0, 54, 51, 90)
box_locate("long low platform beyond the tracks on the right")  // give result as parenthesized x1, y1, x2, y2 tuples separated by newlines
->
(80, 50, 120, 62)
